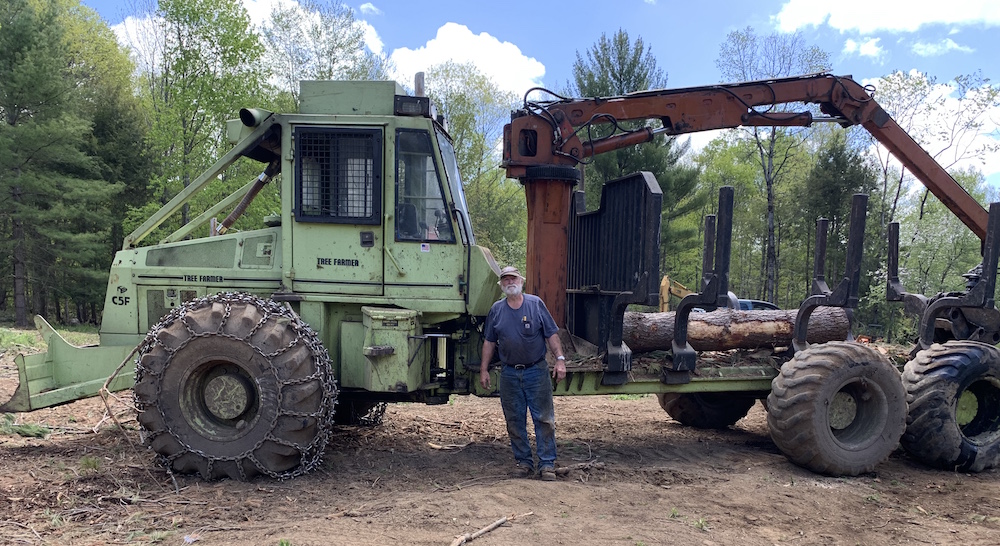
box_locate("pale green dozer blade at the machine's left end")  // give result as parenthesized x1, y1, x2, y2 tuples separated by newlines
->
(0, 316, 135, 412)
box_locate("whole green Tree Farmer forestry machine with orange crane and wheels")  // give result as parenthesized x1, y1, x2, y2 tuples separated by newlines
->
(0, 74, 1000, 480)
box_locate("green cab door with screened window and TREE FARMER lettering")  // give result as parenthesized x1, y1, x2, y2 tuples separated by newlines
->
(292, 126, 384, 296)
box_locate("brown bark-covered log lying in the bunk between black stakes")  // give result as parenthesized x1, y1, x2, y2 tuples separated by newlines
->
(622, 307, 851, 352)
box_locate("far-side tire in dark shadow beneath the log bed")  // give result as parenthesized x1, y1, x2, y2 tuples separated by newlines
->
(656, 392, 756, 428)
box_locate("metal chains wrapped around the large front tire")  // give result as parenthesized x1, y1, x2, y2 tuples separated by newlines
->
(135, 292, 340, 481)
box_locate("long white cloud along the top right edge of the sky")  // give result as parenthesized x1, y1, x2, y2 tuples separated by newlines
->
(772, 0, 1000, 34)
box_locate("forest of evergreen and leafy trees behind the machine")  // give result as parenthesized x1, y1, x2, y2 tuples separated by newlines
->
(0, 0, 1000, 341)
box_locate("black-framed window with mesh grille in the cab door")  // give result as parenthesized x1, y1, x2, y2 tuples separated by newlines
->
(295, 128, 382, 224)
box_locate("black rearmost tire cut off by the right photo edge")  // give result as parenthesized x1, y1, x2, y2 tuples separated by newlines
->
(902, 341, 1000, 472)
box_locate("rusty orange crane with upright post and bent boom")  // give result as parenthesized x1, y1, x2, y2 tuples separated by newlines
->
(502, 74, 988, 324)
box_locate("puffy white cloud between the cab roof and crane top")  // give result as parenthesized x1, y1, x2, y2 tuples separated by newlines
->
(389, 23, 545, 95)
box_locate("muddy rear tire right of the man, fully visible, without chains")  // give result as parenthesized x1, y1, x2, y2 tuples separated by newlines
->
(767, 341, 906, 476)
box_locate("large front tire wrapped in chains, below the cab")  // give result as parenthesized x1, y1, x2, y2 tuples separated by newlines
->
(135, 294, 337, 480)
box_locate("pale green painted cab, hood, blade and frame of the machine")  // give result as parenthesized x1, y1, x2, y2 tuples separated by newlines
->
(5, 82, 777, 412)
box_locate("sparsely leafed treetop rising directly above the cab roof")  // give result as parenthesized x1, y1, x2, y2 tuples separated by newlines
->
(261, 0, 391, 103)
